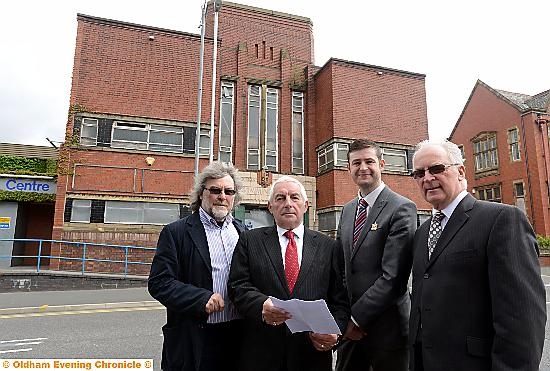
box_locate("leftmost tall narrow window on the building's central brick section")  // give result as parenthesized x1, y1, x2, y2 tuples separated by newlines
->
(218, 81, 234, 162)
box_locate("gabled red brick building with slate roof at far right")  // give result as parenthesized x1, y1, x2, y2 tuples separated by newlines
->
(450, 80, 550, 235)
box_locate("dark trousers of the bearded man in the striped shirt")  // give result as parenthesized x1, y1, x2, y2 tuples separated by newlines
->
(199, 320, 243, 371)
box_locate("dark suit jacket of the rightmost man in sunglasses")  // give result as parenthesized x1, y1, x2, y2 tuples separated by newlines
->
(410, 195, 546, 371)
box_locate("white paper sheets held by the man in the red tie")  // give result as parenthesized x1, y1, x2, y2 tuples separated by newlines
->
(269, 296, 341, 335)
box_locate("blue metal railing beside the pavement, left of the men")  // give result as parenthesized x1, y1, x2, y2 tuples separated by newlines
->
(0, 238, 156, 277)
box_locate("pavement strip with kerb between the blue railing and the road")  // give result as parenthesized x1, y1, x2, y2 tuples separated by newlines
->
(0, 287, 161, 316)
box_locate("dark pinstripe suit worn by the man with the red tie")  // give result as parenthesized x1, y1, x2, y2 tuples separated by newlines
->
(228, 226, 349, 371)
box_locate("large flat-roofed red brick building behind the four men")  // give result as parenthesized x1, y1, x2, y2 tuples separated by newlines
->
(53, 2, 428, 272)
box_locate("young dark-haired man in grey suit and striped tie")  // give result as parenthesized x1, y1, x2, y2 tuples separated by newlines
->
(336, 139, 417, 371)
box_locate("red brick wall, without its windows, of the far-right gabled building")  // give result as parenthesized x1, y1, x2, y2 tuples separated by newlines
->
(450, 81, 550, 235)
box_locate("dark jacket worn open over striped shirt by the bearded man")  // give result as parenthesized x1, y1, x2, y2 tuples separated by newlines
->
(148, 212, 244, 371)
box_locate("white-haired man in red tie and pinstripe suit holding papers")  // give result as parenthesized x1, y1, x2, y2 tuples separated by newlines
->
(228, 176, 349, 371)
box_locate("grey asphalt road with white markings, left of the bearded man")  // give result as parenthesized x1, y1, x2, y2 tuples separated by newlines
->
(0, 308, 165, 370)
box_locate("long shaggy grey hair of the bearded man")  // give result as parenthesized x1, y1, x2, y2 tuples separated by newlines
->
(189, 161, 243, 212)
